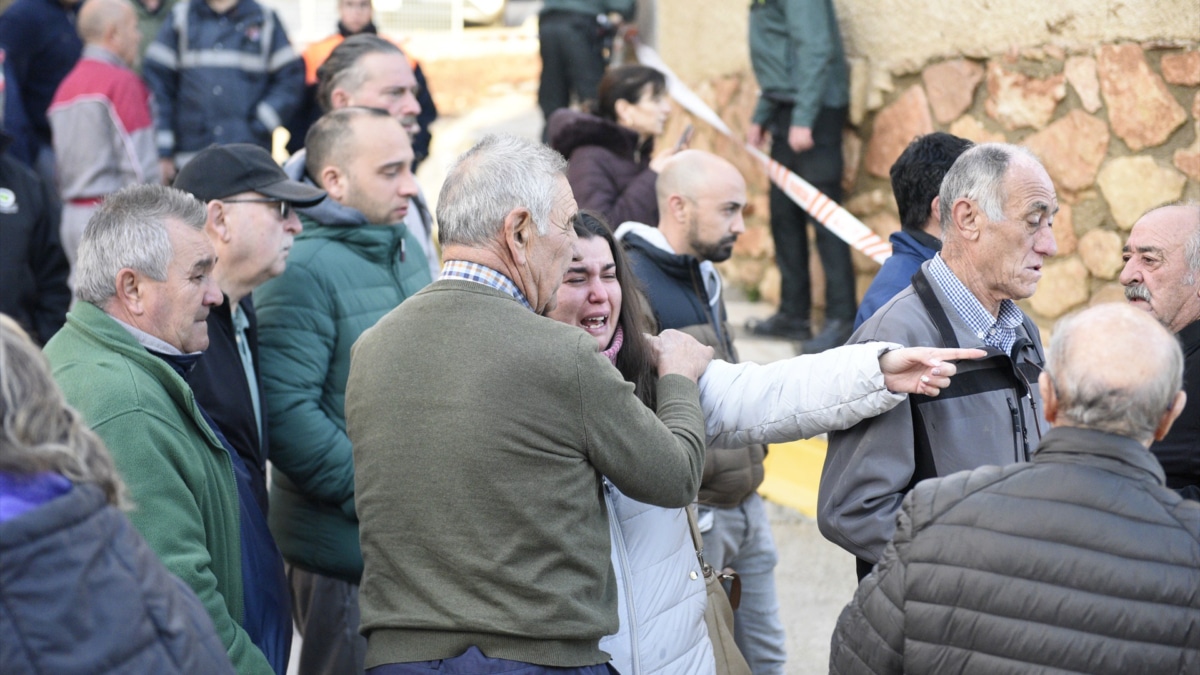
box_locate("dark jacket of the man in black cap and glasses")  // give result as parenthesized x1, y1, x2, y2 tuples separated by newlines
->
(187, 295, 268, 515)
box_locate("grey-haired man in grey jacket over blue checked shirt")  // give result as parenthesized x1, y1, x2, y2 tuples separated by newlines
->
(817, 143, 1058, 579)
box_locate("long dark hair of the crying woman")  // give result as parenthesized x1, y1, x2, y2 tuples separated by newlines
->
(571, 210, 658, 410)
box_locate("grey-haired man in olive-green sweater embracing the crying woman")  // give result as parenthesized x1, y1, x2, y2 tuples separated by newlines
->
(346, 136, 713, 675)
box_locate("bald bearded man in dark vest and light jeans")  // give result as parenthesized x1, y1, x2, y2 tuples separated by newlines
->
(617, 150, 787, 673)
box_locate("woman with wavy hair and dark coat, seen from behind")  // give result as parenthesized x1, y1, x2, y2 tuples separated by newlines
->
(0, 315, 233, 675)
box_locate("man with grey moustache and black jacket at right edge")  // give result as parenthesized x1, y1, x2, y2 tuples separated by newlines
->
(1121, 202, 1200, 500)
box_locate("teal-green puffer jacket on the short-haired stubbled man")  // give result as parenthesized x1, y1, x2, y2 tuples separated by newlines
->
(254, 212, 431, 584)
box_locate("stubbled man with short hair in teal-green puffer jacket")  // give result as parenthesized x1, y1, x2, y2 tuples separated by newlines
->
(254, 106, 431, 675)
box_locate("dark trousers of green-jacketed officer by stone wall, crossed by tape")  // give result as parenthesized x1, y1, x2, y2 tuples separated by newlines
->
(768, 106, 857, 322)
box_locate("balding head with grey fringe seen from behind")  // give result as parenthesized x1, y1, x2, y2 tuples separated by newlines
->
(1039, 303, 1183, 444)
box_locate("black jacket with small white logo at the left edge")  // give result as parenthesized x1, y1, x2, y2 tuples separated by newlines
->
(0, 148, 71, 345)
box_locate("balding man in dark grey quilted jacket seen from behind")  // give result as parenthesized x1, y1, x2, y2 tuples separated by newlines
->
(829, 304, 1200, 675)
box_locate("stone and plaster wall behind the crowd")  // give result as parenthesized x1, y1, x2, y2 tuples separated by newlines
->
(656, 0, 1200, 328)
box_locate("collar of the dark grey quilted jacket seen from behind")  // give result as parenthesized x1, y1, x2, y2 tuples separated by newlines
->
(1033, 426, 1166, 485)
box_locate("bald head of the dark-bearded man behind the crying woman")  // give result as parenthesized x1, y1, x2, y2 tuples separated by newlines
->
(655, 150, 746, 262)
